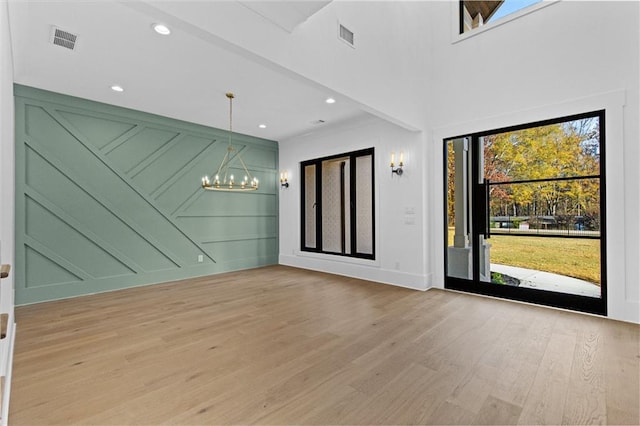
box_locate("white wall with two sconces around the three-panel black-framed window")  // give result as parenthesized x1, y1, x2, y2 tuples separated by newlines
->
(280, 116, 427, 289)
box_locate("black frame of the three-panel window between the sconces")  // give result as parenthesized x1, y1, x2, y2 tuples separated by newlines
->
(300, 147, 376, 260)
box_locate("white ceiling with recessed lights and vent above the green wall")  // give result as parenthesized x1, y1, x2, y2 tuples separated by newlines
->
(9, 0, 367, 140)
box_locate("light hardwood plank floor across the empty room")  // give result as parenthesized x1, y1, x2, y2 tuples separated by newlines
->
(9, 266, 640, 425)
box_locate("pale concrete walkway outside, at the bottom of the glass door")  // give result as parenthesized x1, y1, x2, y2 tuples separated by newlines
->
(491, 263, 600, 297)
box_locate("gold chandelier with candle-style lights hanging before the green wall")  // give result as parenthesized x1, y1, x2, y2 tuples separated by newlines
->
(202, 93, 258, 191)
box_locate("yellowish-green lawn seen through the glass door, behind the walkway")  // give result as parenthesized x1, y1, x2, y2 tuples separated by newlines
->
(449, 230, 600, 284)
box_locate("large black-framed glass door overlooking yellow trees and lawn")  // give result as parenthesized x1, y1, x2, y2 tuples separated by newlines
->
(445, 112, 606, 314)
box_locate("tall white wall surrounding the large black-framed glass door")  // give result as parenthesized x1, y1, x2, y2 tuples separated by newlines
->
(427, 1, 640, 322)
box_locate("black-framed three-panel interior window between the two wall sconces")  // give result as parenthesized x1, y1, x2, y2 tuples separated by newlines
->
(300, 148, 375, 259)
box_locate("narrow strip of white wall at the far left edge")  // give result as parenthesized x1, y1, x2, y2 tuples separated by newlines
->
(0, 2, 15, 296)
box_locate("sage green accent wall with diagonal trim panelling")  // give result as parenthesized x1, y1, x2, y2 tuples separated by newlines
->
(15, 85, 278, 304)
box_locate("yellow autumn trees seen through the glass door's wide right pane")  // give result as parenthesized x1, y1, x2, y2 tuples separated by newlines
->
(483, 117, 600, 225)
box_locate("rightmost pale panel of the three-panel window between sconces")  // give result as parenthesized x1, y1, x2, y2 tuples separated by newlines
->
(355, 155, 373, 254)
